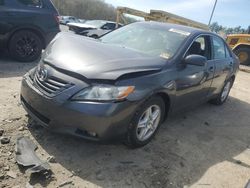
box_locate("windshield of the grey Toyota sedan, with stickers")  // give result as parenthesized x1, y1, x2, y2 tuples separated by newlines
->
(100, 23, 190, 59)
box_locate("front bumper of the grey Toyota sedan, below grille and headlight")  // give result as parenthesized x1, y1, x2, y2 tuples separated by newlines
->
(21, 75, 137, 140)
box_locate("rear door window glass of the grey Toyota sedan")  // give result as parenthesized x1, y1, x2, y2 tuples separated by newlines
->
(213, 37, 226, 59)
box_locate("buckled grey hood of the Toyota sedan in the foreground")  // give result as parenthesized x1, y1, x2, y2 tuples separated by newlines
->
(43, 33, 167, 80)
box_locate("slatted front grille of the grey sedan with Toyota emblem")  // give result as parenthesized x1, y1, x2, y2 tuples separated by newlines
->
(34, 71, 72, 96)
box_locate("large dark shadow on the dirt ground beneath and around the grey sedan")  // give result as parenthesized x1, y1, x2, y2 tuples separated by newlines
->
(26, 97, 250, 188)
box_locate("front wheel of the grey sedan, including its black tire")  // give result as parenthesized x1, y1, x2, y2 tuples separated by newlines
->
(125, 96, 166, 148)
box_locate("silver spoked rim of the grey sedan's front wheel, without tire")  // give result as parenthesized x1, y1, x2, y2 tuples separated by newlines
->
(136, 105, 161, 141)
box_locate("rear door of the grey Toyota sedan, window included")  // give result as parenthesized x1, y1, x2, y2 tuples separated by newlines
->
(210, 36, 233, 95)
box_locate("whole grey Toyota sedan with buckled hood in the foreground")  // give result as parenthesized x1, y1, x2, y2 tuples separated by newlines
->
(21, 22, 239, 147)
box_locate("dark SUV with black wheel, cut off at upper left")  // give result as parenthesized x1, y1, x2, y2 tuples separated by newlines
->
(0, 0, 60, 62)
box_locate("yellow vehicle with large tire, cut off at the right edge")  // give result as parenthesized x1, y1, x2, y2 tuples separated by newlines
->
(227, 34, 250, 65)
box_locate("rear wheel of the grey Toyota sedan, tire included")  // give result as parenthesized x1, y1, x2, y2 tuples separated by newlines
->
(209, 79, 233, 105)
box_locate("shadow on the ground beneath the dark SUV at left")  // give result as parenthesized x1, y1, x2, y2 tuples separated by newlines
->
(0, 51, 39, 78)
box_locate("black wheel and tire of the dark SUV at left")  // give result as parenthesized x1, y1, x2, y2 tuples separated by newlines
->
(9, 30, 42, 62)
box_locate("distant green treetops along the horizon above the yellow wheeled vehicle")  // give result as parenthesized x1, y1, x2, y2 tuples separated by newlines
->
(209, 22, 250, 35)
